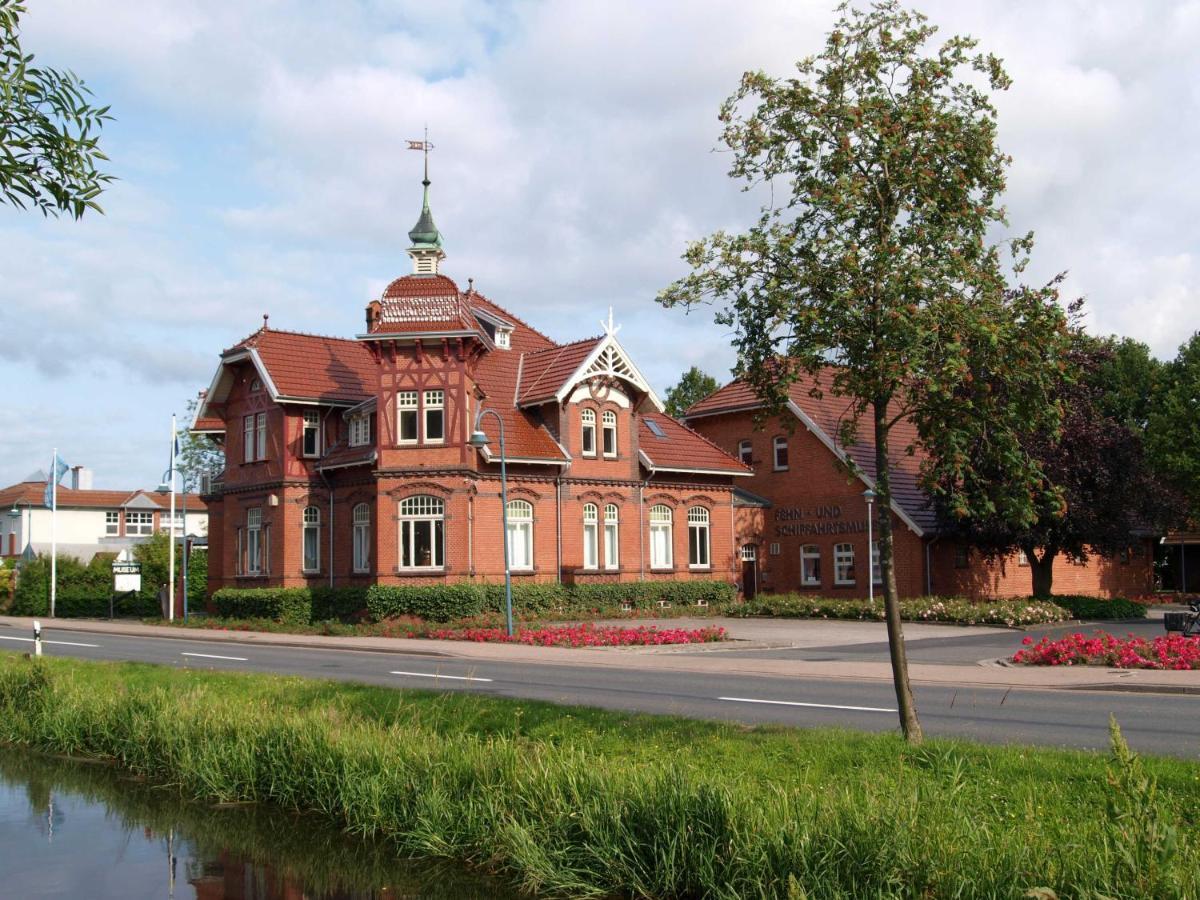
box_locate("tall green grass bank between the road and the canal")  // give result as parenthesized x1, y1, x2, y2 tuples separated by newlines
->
(0, 656, 1200, 899)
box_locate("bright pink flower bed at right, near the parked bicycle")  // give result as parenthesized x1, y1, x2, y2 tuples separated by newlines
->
(1013, 631, 1200, 670)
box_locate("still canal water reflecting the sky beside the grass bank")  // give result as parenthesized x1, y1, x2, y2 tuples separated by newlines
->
(0, 749, 521, 900)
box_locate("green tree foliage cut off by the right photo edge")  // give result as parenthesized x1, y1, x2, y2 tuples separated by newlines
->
(1146, 331, 1200, 522)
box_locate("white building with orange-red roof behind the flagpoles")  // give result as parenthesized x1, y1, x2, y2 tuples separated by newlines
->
(0, 467, 209, 563)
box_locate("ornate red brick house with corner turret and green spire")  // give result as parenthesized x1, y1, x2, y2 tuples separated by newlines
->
(193, 180, 750, 590)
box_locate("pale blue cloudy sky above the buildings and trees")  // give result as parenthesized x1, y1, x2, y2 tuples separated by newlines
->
(0, 0, 1200, 487)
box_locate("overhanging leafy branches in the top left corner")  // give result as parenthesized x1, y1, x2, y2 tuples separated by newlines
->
(0, 0, 113, 218)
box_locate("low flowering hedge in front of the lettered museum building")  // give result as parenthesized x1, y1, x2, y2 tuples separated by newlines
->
(727, 594, 1068, 626)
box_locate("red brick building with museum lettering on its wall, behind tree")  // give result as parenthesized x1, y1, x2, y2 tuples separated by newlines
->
(684, 379, 1153, 596)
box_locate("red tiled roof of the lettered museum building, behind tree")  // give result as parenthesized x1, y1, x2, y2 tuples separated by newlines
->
(684, 370, 937, 534)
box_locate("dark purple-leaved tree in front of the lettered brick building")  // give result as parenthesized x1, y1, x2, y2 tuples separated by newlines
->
(936, 331, 1176, 598)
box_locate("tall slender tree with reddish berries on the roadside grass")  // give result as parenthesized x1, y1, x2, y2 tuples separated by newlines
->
(659, 0, 1066, 742)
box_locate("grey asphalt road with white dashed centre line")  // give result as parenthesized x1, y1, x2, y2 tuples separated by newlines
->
(0, 629, 1200, 760)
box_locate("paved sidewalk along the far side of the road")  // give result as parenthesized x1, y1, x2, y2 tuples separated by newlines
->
(0, 616, 1200, 695)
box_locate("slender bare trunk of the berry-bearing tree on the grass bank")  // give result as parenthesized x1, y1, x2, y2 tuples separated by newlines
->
(866, 397, 924, 744)
